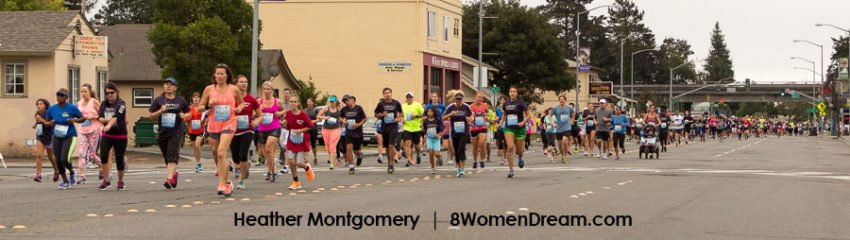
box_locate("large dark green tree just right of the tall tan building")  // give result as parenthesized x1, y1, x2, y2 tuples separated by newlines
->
(463, 0, 575, 102)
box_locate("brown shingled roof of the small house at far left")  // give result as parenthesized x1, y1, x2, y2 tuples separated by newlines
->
(0, 11, 80, 55)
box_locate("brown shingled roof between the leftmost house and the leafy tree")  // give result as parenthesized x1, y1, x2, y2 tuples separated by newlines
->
(100, 24, 162, 81)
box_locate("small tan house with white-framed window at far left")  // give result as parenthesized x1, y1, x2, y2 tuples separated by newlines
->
(0, 11, 109, 156)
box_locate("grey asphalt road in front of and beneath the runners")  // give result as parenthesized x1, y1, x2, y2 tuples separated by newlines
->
(0, 137, 850, 239)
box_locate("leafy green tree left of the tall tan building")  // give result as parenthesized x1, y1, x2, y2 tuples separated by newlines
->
(148, 0, 262, 96)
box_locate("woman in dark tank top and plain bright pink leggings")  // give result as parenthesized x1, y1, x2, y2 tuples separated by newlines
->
(314, 95, 348, 170)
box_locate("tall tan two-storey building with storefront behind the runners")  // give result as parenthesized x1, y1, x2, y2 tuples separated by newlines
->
(247, 0, 463, 110)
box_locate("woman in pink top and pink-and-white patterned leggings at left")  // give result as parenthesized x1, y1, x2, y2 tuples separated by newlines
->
(77, 83, 103, 184)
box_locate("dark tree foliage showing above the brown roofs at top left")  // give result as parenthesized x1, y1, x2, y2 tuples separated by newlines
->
(100, 0, 154, 25)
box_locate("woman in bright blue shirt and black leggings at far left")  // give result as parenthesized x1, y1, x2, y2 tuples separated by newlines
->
(45, 88, 86, 189)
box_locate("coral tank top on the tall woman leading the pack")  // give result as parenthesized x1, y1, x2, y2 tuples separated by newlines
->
(207, 84, 236, 133)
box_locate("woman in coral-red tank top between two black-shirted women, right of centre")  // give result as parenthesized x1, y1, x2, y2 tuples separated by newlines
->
(468, 92, 492, 169)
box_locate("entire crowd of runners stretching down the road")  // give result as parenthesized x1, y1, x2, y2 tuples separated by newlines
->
(33, 64, 822, 196)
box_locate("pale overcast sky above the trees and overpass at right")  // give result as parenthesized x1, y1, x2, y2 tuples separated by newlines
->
(521, 0, 850, 82)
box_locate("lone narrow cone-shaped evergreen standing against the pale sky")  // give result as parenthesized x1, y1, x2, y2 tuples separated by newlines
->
(703, 22, 735, 82)
